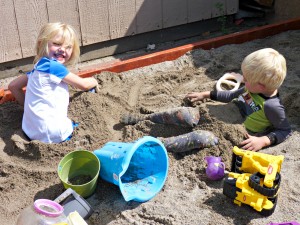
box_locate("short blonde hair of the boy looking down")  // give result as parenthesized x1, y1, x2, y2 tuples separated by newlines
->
(242, 48, 286, 91)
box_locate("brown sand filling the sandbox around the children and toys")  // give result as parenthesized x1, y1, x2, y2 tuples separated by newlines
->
(0, 31, 300, 225)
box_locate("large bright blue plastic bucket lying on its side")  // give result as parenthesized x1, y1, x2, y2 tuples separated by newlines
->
(94, 136, 169, 202)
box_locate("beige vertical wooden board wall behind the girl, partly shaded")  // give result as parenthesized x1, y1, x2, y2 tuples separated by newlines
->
(0, 0, 238, 63)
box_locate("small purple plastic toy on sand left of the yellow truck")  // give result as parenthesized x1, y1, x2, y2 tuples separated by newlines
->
(205, 156, 225, 180)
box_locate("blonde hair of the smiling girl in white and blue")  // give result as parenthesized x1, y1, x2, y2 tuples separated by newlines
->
(34, 22, 80, 65)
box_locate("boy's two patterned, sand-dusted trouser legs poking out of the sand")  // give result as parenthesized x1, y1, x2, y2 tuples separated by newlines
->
(120, 107, 218, 152)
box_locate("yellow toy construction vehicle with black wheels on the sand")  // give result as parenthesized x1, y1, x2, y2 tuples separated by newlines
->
(223, 146, 284, 216)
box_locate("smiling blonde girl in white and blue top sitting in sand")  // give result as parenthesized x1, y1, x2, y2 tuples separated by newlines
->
(8, 22, 97, 143)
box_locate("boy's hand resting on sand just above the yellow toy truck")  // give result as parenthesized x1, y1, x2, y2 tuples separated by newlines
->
(240, 134, 271, 152)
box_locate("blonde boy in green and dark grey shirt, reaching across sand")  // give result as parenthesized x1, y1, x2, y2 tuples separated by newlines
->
(185, 48, 291, 151)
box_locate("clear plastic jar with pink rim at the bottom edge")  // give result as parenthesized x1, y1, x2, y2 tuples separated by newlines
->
(16, 199, 68, 225)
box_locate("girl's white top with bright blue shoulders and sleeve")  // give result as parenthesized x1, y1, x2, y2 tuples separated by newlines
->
(22, 57, 73, 143)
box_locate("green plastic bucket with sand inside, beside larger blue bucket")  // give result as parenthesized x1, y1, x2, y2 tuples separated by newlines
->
(57, 150, 100, 198)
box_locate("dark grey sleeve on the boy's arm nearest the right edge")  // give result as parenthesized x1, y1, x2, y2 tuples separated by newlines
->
(264, 97, 291, 144)
